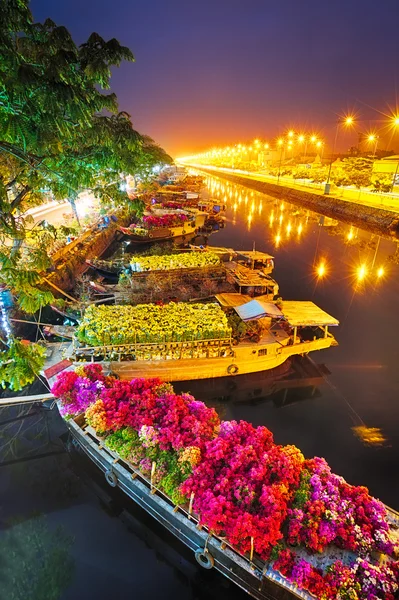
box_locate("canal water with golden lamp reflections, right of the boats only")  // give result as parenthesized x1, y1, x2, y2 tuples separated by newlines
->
(203, 177, 399, 509)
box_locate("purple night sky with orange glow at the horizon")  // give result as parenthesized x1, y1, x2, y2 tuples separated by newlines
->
(31, 0, 399, 156)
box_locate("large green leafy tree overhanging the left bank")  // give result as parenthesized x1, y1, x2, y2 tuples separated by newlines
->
(0, 0, 170, 390)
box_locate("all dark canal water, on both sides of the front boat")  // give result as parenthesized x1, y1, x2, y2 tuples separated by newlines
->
(0, 178, 399, 600)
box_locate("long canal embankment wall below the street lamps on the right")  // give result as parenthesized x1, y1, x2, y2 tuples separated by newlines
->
(200, 167, 399, 240)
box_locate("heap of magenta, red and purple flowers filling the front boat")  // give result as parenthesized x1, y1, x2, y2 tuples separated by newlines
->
(52, 365, 399, 600)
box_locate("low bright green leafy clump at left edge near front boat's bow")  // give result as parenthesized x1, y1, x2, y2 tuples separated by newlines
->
(0, 338, 46, 392)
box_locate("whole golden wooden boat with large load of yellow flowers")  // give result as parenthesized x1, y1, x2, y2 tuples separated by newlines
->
(63, 294, 338, 381)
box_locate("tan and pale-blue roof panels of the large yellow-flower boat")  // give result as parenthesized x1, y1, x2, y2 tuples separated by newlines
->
(234, 296, 339, 327)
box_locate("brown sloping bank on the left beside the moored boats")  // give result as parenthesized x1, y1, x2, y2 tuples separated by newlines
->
(44, 215, 130, 295)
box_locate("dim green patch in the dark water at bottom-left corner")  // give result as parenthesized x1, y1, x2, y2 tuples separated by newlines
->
(0, 517, 74, 600)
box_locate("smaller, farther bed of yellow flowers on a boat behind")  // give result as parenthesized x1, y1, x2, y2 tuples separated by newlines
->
(130, 252, 220, 272)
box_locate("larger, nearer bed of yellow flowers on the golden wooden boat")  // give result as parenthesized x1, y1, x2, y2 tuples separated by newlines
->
(77, 300, 231, 346)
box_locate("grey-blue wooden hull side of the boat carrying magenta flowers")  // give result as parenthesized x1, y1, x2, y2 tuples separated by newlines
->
(61, 416, 399, 600)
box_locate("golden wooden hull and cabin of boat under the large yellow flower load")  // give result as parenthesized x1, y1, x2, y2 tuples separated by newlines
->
(61, 294, 339, 381)
